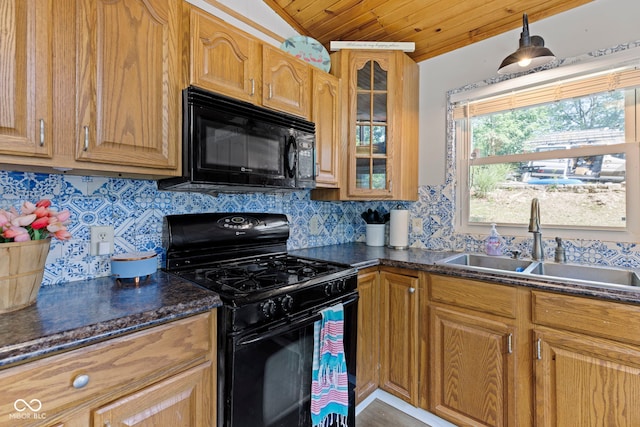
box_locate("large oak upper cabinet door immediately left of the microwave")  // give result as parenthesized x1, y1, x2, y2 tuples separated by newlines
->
(76, 0, 183, 169)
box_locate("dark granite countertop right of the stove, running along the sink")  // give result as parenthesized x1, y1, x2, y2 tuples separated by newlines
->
(290, 243, 640, 304)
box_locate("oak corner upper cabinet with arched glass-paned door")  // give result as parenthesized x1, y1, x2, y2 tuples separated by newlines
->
(313, 50, 418, 200)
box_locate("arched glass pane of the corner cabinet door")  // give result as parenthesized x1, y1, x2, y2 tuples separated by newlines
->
(355, 60, 389, 191)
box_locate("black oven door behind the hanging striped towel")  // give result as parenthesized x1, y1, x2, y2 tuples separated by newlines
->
(222, 294, 358, 427)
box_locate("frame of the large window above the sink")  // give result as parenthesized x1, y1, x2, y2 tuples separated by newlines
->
(448, 49, 640, 242)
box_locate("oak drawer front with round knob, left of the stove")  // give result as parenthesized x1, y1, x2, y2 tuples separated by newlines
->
(0, 313, 212, 426)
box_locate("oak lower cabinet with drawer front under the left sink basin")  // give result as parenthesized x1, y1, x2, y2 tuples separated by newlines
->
(428, 275, 532, 427)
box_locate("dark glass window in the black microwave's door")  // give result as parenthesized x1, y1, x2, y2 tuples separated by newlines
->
(199, 116, 284, 176)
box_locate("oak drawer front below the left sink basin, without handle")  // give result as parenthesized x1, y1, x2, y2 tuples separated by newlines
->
(429, 275, 517, 319)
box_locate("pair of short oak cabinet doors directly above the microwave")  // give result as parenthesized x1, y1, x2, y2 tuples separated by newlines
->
(189, 7, 311, 119)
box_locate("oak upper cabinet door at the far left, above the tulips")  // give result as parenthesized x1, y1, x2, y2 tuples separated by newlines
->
(0, 0, 53, 157)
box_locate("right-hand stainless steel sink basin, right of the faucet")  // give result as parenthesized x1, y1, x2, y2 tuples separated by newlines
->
(528, 262, 640, 287)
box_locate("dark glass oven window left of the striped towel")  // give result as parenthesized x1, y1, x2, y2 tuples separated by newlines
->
(231, 323, 313, 427)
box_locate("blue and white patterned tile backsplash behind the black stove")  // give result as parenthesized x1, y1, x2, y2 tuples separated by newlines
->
(0, 171, 408, 285)
